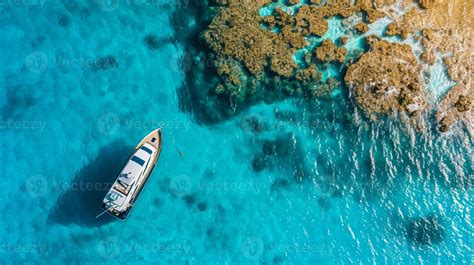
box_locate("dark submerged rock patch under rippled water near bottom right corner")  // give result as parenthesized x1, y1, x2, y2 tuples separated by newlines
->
(407, 215, 445, 245)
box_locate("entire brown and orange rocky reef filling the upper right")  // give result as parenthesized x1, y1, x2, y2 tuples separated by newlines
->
(175, 0, 473, 132)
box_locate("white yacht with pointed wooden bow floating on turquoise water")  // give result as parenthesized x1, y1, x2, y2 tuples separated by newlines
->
(98, 129, 162, 220)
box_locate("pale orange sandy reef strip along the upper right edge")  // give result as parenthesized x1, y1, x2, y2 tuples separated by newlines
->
(380, 0, 474, 131)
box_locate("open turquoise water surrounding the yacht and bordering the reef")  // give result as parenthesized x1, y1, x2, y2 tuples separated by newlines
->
(0, 0, 473, 264)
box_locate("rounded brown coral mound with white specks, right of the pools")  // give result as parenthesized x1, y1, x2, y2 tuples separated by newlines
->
(345, 37, 426, 116)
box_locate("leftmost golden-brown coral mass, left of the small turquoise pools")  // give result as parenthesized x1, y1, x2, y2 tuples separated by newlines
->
(204, 1, 296, 76)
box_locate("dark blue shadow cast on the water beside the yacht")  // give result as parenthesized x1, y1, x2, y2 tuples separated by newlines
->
(48, 141, 133, 227)
